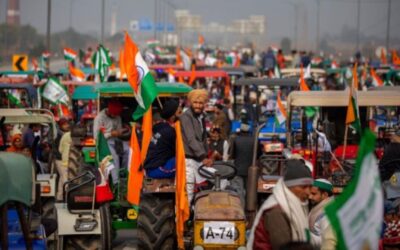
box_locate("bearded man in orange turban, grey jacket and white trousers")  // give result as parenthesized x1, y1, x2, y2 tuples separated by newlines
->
(179, 89, 212, 203)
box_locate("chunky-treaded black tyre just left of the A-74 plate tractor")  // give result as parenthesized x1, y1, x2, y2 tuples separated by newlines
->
(137, 194, 176, 250)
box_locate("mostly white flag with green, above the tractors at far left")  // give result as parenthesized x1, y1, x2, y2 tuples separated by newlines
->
(41, 77, 69, 105)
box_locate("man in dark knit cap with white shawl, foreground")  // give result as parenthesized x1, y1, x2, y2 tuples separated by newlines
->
(247, 159, 313, 249)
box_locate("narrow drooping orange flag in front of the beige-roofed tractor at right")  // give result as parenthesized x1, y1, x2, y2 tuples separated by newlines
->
(346, 64, 361, 132)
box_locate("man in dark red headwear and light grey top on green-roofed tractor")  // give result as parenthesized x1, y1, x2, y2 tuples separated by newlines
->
(93, 100, 129, 184)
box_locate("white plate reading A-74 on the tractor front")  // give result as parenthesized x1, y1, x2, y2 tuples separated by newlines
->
(203, 221, 237, 244)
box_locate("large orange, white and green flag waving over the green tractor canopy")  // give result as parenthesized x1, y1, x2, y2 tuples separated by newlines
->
(124, 33, 157, 120)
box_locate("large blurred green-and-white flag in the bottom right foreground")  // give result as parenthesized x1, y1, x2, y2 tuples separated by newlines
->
(325, 130, 384, 250)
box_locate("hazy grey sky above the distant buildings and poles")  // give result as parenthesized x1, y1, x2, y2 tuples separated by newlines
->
(0, 0, 400, 44)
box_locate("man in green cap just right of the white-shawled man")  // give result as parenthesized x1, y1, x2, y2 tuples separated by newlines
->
(308, 179, 333, 247)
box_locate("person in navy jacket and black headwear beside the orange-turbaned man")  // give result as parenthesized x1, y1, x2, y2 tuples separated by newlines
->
(144, 99, 180, 179)
